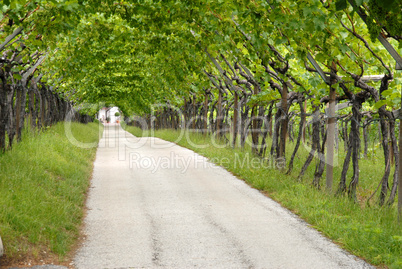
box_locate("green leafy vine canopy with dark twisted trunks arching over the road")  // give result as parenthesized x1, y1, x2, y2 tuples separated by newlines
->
(0, 0, 402, 214)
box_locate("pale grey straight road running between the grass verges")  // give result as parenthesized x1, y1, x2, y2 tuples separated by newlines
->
(74, 126, 371, 269)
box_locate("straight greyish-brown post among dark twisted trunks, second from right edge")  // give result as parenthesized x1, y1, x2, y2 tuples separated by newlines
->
(326, 86, 336, 192)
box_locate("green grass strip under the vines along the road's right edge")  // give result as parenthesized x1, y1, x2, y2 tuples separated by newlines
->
(126, 126, 402, 268)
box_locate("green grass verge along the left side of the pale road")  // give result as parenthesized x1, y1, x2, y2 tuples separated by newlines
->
(0, 123, 102, 259)
